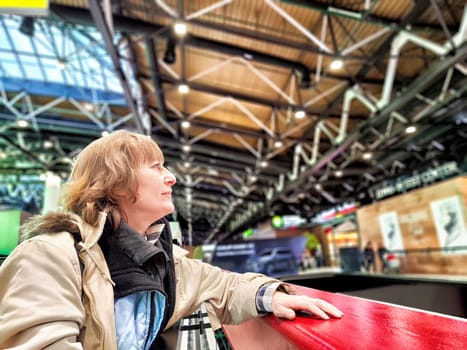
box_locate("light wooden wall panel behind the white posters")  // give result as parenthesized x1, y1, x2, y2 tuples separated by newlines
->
(357, 176, 467, 275)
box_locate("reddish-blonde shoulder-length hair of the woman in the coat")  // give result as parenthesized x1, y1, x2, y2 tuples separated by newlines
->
(62, 130, 163, 227)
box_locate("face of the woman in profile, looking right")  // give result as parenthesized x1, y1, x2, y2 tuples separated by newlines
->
(119, 161, 177, 228)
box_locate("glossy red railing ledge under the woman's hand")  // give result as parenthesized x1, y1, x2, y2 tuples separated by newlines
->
(224, 286, 467, 350)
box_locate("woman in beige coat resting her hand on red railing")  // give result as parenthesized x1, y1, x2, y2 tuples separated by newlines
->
(0, 131, 342, 350)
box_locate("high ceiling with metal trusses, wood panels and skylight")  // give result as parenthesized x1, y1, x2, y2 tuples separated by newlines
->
(0, 0, 467, 244)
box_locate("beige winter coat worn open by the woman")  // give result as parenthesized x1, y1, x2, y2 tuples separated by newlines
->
(0, 214, 274, 350)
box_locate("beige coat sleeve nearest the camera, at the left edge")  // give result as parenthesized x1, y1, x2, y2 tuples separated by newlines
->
(0, 235, 85, 350)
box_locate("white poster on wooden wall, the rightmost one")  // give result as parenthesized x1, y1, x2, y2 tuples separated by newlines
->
(430, 196, 467, 253)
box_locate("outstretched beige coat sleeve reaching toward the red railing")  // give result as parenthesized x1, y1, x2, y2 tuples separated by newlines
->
(169, 245, 277, 326)
